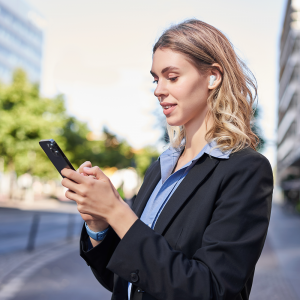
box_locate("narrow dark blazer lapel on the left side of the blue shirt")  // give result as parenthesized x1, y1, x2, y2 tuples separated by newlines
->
(132, 160, 161, 218)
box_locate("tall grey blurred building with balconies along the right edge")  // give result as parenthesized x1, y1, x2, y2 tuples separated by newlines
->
(277, 0, 300, 203)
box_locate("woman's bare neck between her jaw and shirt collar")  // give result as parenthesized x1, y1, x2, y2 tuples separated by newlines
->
(182, 109, 212, 160)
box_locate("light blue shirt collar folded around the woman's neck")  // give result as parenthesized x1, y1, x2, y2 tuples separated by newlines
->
(159, 139, 232, 183)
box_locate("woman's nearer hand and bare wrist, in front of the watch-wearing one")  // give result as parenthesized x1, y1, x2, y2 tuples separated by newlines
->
(61, 166, 138, 238)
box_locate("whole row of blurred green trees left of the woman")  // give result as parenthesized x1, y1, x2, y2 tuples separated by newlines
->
(0, 69, 158, 178)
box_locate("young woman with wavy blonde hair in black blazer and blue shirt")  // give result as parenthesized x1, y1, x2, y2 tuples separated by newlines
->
(62, 20, 273, 300)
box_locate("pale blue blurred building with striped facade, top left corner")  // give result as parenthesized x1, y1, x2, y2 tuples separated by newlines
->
(0, 0, 45, 83)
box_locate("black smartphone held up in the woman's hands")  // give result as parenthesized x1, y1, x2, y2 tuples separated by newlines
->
(39, 139, 75, 177)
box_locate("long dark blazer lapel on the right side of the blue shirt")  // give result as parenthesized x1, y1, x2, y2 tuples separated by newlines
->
(154, 154, 219, 234)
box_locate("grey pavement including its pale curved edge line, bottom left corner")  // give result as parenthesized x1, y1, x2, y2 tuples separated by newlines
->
(0, 239, 111, 300)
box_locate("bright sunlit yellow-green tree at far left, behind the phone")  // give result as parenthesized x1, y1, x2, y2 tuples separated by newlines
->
(0, 70, 66, 176)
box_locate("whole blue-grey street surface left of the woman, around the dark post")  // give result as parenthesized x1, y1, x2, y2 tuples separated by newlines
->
(0, 208, 111, 300)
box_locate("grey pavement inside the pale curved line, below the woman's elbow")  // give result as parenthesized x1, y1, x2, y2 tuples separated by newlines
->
(9, 249, 111, 300)
